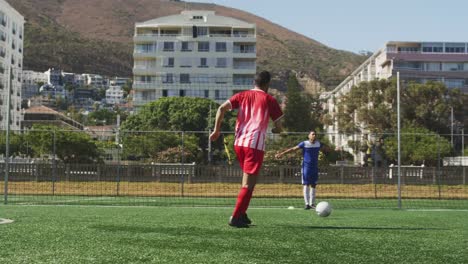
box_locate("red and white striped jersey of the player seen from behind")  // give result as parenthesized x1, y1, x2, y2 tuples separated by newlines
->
(229, 88, 283, 151)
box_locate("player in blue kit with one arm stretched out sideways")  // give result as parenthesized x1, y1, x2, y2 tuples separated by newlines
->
(275, 130, 324, 210)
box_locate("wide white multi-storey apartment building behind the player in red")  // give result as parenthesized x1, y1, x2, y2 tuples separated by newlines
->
(133, 11, 257, 108)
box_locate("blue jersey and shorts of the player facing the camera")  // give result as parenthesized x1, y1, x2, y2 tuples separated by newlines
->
(297, 140, 321, 185)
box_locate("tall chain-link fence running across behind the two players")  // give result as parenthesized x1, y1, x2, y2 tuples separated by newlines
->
(0, 129, 468, 209)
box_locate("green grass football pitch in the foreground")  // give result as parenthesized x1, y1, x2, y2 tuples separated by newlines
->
(0, 203, 468, 263)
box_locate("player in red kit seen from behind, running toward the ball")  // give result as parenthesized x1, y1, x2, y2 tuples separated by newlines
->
(210, 71, 283, 227)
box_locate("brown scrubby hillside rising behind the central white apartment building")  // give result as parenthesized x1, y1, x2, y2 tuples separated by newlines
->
(7, 0, 365, 92)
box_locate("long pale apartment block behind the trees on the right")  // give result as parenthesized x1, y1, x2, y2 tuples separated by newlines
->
(321, 41, 468, 161)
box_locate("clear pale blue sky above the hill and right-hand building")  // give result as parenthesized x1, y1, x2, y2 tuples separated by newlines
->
(187, 0, 468, 52)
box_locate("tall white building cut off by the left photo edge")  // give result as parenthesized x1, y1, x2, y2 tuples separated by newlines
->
(0, 0, 24, 130)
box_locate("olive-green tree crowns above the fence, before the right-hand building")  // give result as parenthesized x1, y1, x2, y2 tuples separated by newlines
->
(337, 80, 462, 133)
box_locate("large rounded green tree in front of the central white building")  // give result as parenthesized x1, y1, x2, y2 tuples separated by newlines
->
(122, 97, 235, 162)
